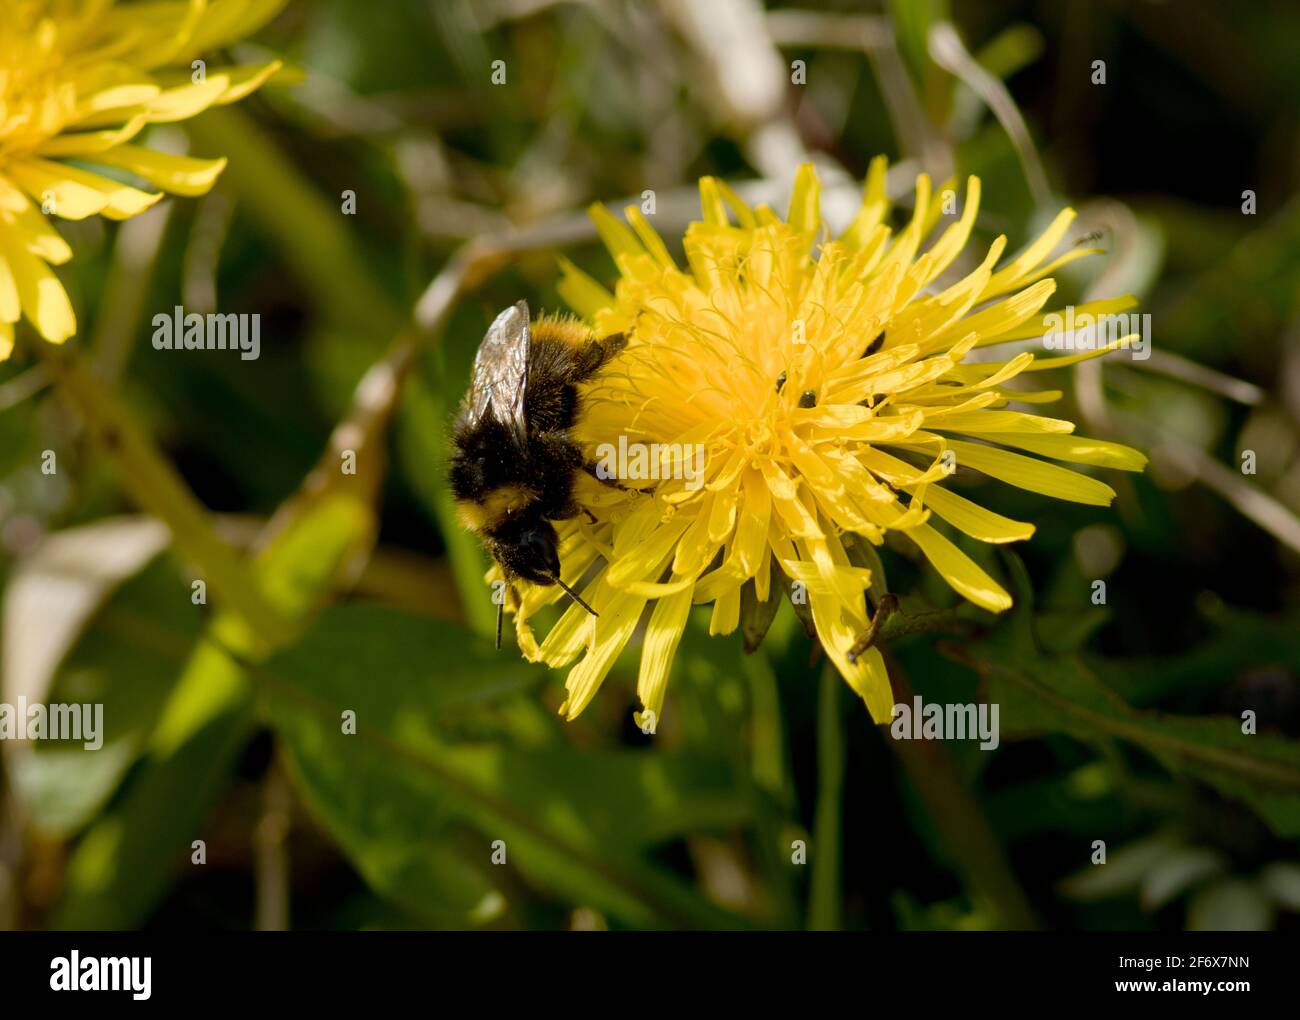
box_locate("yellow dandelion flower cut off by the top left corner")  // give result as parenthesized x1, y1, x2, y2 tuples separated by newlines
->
(0, 0, 285, 360)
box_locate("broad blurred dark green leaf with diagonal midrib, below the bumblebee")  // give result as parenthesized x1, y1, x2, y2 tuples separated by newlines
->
(257, 604, 750, 926)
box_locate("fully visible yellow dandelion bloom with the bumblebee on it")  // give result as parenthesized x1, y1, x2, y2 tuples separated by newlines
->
(506, 160, 1145, 721)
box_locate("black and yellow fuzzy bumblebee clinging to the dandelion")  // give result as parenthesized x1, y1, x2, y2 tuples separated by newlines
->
(450, 301, 627, 648)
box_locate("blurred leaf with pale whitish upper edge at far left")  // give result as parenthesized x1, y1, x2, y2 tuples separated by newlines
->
(3, 517, 199, 837)
